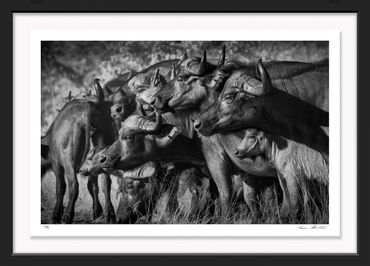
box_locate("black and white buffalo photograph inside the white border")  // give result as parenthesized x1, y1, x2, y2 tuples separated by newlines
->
(40, 40, 335, 225)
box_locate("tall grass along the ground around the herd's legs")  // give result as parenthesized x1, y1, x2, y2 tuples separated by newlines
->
(41, 172, 329, 224)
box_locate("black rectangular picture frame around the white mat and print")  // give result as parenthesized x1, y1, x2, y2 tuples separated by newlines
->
(0, 0, 370, 265)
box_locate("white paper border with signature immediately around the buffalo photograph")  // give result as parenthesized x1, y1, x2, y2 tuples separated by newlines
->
(31, 31, 342, 237)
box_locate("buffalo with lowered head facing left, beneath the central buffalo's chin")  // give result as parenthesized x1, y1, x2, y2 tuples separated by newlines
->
(94, 113, 204, 170)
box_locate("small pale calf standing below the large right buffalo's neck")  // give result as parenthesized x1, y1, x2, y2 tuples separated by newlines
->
(235, 128, 329, 221)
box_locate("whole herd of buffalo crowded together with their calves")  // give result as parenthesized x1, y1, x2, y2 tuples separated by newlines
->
(41, 46, 329, 223)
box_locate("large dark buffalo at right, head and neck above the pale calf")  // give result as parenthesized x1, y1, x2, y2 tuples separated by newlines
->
(194, 61, 329, 154)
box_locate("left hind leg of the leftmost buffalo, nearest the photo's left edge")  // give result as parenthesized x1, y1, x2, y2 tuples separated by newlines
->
(52, 166, 66, 223)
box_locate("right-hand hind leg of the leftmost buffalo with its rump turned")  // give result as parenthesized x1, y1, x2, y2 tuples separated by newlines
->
(62, 169, 79, 224)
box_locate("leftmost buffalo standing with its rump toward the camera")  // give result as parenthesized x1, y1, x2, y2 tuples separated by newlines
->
(41, 80, 117, 223)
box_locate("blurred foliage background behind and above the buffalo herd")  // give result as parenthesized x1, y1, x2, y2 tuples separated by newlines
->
(41, 41, 329, 224)
